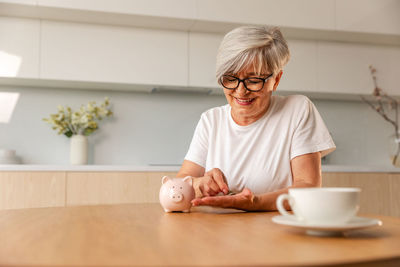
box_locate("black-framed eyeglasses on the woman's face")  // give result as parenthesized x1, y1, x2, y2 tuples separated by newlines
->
(219, 73, 273, 92)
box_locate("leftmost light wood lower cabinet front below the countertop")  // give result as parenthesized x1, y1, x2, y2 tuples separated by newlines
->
(0, 172, 65, 210)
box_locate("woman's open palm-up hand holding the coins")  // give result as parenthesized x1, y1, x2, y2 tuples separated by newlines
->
(192, 188, 257, 211)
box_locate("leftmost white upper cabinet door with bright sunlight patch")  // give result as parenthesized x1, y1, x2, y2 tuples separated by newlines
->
(0, 17, 40, 78)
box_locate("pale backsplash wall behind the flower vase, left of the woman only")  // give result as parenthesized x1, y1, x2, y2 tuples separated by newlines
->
(0, 87, 224, 165)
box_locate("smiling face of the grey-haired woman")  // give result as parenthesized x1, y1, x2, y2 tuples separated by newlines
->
(224, 68, 282, 125)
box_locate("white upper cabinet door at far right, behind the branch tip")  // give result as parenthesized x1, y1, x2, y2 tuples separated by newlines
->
(317, 42, 400, 95)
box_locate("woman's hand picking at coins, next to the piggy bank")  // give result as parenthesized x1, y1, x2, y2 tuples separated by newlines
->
(193, 168, 229, 198)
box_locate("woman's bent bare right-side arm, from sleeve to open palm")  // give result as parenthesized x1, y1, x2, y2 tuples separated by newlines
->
(192, 152, 322, 211)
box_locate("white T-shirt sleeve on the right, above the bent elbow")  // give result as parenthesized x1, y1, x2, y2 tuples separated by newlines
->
(290, 98, 336, 159)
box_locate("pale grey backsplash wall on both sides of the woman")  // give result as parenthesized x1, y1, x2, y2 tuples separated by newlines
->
(0, 87, 392, 166)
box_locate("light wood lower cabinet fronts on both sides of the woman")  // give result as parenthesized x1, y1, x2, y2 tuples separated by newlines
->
(0, 171, 400, 217)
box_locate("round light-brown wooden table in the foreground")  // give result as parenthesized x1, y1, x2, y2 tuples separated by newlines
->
(0, 204, 400, 266)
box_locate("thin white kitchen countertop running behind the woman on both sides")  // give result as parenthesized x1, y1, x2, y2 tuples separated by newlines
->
(0, 164, 400, 173)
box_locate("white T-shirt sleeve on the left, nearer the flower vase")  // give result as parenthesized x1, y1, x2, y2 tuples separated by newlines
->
(185, 114, 209, 168)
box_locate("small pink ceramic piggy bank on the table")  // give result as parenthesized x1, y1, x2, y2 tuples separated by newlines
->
(160, 176, 195, 212)
